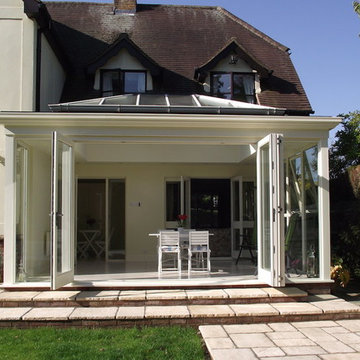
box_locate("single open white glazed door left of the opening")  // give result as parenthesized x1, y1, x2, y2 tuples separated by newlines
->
(51, 131, 74, 289)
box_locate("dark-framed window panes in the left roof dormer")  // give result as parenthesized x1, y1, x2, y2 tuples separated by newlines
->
(100, 69, 146, 97)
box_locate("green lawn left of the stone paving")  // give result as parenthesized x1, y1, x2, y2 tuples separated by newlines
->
(0, 327, 204, 360)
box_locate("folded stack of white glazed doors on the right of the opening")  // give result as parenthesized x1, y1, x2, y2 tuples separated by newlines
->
(257, 134, 285, 286)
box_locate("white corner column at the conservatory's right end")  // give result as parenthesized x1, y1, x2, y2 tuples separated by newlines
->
(318, 137, 331, 280)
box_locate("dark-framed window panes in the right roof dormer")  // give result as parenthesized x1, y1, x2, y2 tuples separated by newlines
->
(210, 72, 256, 104)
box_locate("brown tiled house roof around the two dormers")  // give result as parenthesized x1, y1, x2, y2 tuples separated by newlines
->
(42, 2, 312, 113)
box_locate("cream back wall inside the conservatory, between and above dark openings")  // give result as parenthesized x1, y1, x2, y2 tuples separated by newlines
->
(76, 163, 255, 261)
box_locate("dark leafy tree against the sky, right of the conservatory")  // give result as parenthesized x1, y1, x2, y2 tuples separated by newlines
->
(330, 111, 360, 179)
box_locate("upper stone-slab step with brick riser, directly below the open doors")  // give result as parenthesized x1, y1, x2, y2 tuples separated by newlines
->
(0, 287, 308, 307)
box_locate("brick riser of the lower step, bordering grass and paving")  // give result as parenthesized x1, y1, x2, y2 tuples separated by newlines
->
(0, 312, 360, 329)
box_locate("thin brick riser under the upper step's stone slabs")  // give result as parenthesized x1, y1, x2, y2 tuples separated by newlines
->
(0, 296, 307, 307)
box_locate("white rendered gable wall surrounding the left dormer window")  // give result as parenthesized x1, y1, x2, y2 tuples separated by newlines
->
(94, 49, 153, 91)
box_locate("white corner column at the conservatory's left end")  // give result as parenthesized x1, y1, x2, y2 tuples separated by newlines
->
(4, 134, 16, 284)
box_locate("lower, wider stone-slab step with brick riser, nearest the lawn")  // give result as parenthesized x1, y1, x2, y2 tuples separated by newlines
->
(0, 295, 360, 328)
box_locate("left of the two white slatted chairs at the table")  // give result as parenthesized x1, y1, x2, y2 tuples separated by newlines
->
(158, 231, 181, 278)
